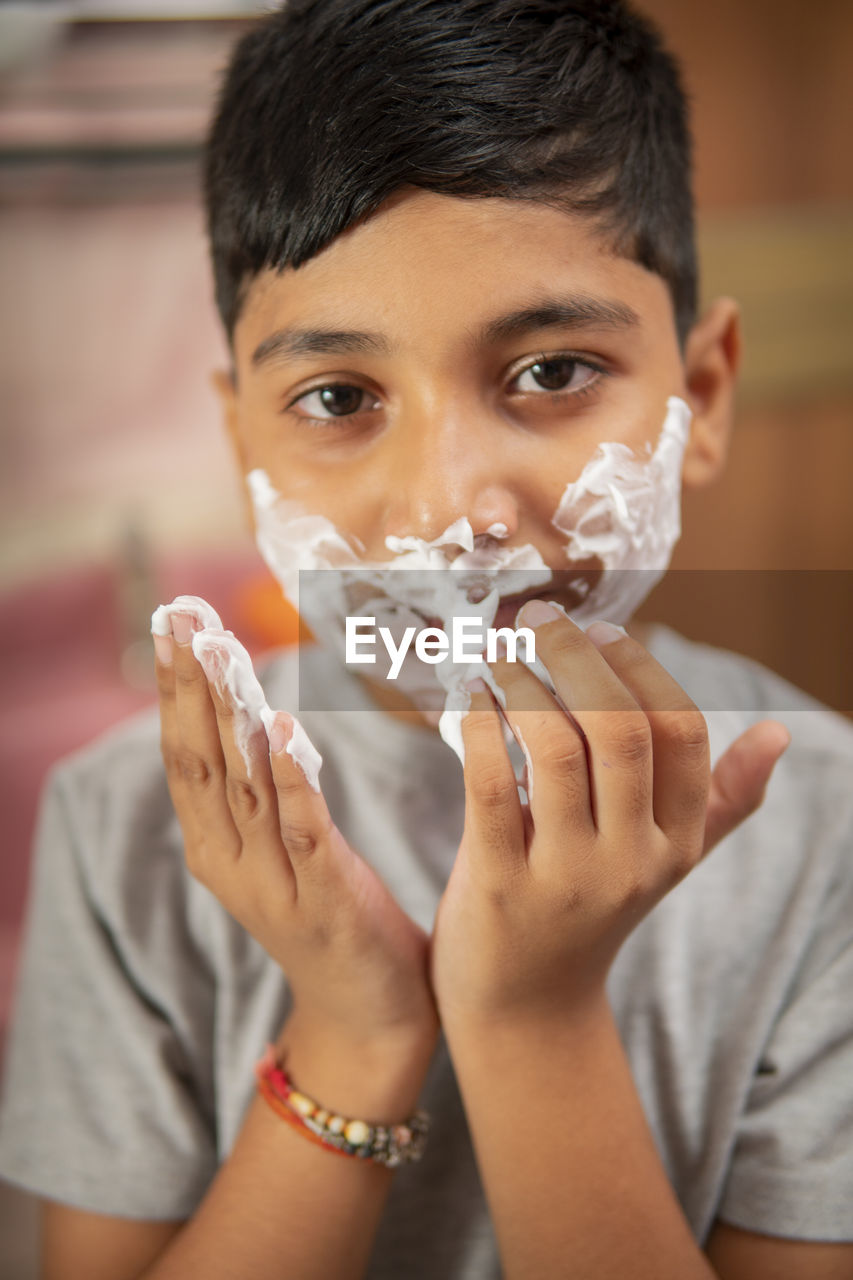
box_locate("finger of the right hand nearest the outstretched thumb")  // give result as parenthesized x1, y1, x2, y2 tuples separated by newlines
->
(587, 622, 710, 858)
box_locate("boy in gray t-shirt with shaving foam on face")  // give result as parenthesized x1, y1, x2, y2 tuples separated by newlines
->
(1, 0, 853, 1280)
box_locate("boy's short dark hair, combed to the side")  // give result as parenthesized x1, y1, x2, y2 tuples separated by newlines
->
(205, 0, 697, 343)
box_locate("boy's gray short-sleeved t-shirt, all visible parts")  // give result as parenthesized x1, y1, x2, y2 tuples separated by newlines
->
(0, 628, 853, 1280)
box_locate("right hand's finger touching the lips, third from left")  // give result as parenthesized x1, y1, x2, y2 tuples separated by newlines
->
(519, 600, 653, 846)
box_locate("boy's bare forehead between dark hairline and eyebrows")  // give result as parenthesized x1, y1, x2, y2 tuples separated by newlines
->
(230, 188, 672, 360)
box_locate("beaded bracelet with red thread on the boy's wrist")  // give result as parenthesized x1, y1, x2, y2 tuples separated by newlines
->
(255, 1044, 429, 1169)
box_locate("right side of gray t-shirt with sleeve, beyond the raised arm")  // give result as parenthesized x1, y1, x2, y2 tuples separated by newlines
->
(611, 628, 853, 1240)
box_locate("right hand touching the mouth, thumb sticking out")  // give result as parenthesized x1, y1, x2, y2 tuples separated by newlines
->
(432, 602, 789, 1028)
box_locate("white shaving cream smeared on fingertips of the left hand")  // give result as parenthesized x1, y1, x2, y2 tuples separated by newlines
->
(151, 595, 323, 791)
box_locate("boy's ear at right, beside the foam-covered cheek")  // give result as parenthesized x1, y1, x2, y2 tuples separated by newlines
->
(681, 298, 740, 489)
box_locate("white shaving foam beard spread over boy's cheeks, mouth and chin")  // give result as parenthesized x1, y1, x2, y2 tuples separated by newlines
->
(247, 396, 690, 760)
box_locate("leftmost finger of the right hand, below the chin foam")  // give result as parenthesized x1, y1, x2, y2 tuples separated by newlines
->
(462, 680, 526, 883)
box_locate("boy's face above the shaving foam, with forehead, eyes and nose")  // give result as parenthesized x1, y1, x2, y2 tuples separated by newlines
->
(223, 188, 722, 691)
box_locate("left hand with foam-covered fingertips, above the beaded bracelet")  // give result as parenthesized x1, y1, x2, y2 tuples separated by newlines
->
(150, 612, 438, 1048)
